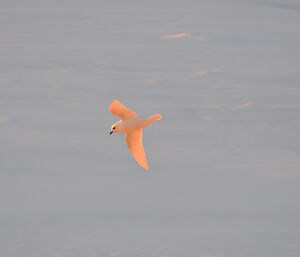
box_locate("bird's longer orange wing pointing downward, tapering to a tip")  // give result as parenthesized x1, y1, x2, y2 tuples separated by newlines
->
(125, 129, 148, 170)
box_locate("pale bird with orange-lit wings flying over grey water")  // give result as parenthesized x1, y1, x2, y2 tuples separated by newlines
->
(109, 100, 162, 170)
